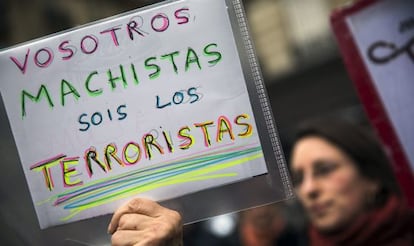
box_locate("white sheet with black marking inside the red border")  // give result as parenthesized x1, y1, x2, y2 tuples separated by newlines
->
(347, 0, 414, 173)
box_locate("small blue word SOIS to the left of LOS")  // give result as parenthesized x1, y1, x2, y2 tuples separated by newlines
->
(78, 104, 127, 132)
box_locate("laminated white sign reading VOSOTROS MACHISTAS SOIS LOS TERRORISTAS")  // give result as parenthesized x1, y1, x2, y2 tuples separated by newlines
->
(0, 0, 292, 228)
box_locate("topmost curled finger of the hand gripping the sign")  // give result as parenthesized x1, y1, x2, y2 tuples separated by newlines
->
(108, 198, 163, 234)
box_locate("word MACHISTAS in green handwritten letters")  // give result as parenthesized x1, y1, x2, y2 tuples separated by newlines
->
(21, 43, 222, 118)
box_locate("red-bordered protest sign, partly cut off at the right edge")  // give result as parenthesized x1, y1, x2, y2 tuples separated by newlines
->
(332, 0, 414, 206)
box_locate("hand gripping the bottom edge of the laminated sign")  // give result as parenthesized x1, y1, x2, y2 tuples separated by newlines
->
(108, 198, 183, 246)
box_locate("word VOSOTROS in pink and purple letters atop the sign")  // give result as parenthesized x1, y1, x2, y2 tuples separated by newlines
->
(10, 8, 190, 74)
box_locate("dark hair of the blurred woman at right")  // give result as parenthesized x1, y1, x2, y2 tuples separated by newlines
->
(294, 119, 400, 205)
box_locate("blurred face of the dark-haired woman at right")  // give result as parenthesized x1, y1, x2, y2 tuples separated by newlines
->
(291, 136, 378, 232)
